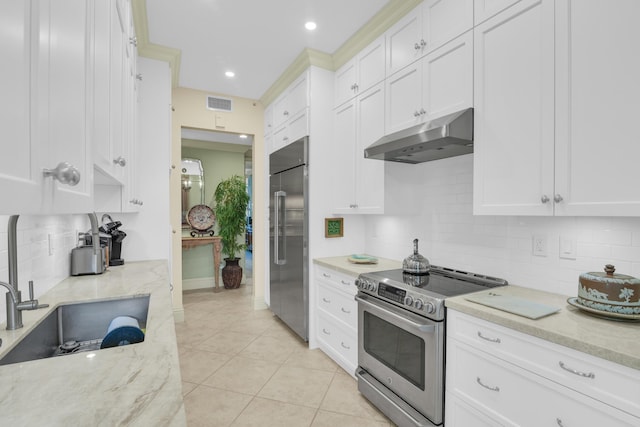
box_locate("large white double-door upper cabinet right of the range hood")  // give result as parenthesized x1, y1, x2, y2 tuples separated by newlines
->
(474, 0, 640, 216)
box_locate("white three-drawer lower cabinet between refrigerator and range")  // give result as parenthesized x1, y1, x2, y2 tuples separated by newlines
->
(314, 265, 358, 376)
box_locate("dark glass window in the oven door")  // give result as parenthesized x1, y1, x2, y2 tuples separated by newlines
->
(363, 311, 425, 390)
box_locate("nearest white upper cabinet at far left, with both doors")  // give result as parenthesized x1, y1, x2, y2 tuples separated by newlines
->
(0, 0, 93, 214)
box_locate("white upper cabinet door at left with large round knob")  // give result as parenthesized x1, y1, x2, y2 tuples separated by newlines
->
(36, 0, 93, 213)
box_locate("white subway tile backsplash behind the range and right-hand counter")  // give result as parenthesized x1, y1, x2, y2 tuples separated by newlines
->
(365, 155, 640, 296)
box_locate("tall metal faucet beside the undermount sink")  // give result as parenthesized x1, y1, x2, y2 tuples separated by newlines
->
(0, 215, 49, 330)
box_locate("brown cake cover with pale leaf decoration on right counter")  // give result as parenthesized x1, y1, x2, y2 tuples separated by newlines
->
(578, 264, 640, 314)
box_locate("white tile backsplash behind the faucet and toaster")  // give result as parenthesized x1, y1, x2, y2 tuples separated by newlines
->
(0, 215, 90, 327)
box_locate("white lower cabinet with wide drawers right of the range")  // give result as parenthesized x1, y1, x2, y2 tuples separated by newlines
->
(445, 310, 640, 427)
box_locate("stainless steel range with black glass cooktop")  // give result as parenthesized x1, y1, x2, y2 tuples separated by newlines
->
(356, 266, 507, 426)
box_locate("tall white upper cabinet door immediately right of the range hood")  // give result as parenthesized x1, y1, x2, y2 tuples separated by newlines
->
(473, 0, 554, 215)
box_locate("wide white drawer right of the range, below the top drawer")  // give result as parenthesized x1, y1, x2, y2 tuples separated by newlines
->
(447, 339, 640, 427)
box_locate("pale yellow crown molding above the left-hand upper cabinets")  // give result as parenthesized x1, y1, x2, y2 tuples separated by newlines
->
(131, 0, 182, 87)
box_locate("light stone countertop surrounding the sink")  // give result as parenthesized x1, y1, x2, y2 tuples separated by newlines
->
(0, 260, 186, 427)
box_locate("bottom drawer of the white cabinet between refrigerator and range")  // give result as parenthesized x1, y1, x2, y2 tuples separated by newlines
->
(317, 310, 358, 375)
